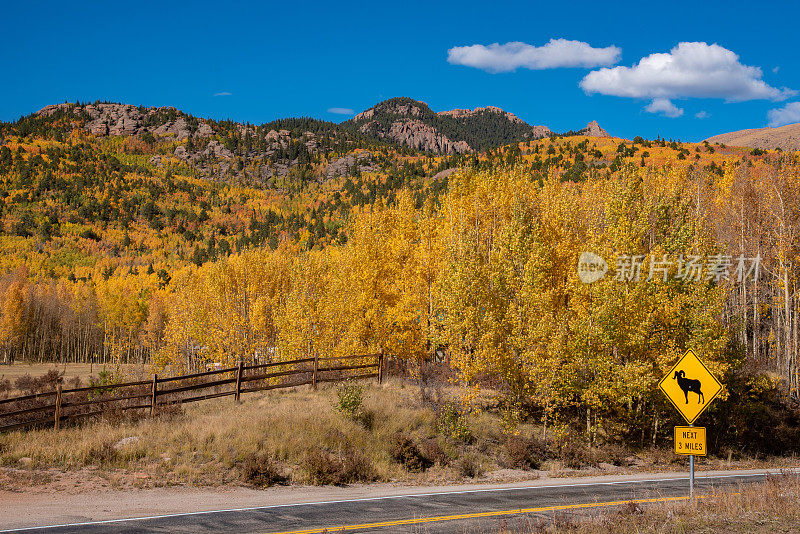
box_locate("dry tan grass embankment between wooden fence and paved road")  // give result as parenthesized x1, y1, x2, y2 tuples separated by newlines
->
(0, 370, 794, 491)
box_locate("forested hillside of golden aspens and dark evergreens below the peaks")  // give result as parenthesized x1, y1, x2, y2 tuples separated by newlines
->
(0, 104, 800, 448)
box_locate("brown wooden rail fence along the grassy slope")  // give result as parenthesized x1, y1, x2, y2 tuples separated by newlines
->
(0, 352, 384, 432)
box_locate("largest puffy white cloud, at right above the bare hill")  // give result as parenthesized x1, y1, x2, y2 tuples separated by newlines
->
(580, 42, 796, 107)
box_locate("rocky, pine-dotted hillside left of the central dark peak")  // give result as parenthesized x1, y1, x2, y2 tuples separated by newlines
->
(28, 102, 375, 183)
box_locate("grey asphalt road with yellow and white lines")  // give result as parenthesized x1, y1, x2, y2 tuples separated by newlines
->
(0, 473, 788, 534)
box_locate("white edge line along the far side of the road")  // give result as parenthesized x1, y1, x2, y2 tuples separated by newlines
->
(0, 474, 800, 533)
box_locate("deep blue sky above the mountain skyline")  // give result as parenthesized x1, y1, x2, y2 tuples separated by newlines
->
(0, 0, 800, 141)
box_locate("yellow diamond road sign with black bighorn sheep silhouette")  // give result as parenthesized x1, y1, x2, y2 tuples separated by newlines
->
(658, 350, 722, 424)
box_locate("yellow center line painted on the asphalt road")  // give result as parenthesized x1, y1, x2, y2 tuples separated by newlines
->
(264, 495, 720, 534)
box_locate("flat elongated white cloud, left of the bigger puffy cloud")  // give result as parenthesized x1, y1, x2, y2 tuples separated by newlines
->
(447, 39, 622, 73)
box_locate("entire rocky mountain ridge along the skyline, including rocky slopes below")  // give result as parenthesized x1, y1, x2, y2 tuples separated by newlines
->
(0, 98, 608, 184)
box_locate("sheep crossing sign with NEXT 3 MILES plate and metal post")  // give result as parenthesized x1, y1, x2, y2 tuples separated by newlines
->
(658, 350, 722, 496)
